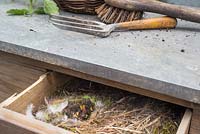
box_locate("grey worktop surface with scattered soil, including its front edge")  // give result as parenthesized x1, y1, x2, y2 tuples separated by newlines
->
(0, 1, 200, 104)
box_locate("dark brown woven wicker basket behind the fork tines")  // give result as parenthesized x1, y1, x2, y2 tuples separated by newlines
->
(54, 0, 104, 14)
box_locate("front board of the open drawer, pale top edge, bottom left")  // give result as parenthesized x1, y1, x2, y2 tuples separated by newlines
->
(0, 108, 72, 134)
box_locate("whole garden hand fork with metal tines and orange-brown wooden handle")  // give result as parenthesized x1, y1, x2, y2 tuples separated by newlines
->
(50, 15, 177, 37)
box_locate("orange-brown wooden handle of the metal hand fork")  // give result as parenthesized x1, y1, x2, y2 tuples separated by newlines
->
(114, 17, 177, 30)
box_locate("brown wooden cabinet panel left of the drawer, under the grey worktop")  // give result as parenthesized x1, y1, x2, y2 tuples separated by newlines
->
(0, 53, 46, 102)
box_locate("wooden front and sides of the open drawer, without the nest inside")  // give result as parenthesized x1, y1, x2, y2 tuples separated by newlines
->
(0, 72, 192, 134)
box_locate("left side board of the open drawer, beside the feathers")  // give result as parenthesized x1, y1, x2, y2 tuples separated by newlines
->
(4, 72, 71, 113)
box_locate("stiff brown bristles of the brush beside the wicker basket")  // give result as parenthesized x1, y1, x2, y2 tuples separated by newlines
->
(95, 3, 143, 23)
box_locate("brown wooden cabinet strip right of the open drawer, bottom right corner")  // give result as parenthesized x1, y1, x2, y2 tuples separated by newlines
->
(189, 107, 200, 134)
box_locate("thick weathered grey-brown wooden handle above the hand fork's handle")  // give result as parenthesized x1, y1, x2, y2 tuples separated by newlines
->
(105, 0, 200, 23)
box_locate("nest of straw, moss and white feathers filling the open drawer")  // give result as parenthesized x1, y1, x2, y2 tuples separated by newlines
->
(26, 80, 184, 134)
